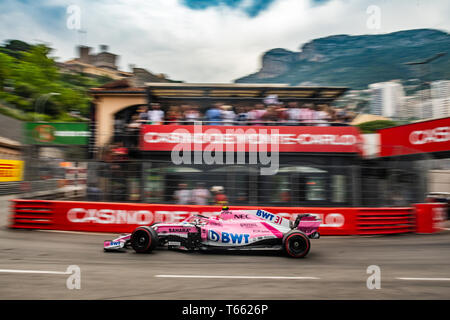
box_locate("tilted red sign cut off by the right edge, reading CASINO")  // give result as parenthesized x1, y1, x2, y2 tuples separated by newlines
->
(378, 117, 450, 157)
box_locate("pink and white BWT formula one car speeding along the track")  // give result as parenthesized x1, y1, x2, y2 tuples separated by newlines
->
(103, 207, 320, 258)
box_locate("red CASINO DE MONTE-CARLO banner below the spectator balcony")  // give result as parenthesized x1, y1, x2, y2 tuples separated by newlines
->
(140, 125, 362, 153)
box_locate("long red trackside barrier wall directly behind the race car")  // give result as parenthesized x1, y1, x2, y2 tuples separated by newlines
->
(10, 199, 441, 235)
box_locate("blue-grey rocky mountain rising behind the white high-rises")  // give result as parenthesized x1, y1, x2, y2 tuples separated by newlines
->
(235, 29, 450, 89)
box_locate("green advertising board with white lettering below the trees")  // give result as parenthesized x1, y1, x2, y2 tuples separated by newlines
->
(25, 122, 90, 145)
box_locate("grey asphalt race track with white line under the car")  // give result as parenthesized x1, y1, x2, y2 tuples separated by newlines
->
(0, 197, 450, 300)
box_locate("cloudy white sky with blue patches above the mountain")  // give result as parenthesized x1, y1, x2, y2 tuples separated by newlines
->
(0, 0, 450, 82)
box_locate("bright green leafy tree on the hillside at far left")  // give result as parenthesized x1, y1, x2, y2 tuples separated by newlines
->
(0, 40, 105, 121)
